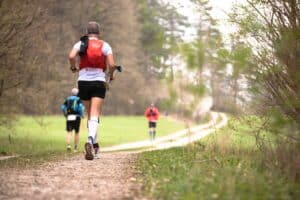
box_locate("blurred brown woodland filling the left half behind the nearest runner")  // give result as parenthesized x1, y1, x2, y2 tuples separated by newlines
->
(0, 0, 163, 115)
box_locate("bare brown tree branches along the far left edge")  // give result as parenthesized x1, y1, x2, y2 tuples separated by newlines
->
(0, 0, 43, 125)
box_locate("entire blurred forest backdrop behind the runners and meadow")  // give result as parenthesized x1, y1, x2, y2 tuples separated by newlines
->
(0, 0, 300, 124)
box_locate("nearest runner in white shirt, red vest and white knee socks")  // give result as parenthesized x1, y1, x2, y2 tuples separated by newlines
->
(69, 22, 116, 160)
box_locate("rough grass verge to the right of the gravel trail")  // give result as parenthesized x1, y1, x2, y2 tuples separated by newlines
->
(138, 116, 300, 200)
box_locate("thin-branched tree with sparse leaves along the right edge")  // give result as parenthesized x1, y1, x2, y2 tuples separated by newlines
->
(231, 0, 300, 124)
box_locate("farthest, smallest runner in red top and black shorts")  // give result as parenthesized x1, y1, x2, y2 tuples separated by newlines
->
(145, 103, 159, 141)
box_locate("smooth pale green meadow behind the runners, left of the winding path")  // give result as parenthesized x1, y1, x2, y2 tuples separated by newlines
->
(0, 116, 184, 166)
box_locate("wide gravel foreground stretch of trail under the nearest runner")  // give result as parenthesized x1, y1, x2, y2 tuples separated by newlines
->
(0, 152, 143, 199)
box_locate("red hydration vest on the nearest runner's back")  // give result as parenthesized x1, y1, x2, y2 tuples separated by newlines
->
(79, 39, 106, 71)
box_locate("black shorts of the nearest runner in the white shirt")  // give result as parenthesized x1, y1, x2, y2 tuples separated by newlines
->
(78, 81, 106, 101)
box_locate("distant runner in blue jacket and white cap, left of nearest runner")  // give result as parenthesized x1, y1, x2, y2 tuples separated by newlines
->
(61, 88, 84, 152)
